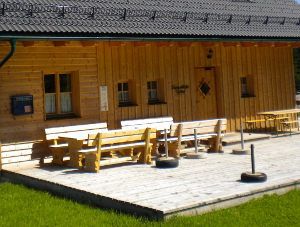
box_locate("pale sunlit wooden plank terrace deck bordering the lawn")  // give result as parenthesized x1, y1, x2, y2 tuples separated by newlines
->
(1, 134, 300, 219)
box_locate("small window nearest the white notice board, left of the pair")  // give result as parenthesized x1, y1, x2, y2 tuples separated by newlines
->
(118, 80, 137, 107)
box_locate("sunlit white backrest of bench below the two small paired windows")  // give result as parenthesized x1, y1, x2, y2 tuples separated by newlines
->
(121, 116, 174, 130)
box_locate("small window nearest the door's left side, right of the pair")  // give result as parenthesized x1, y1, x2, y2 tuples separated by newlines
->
(147, 79, 166, 105)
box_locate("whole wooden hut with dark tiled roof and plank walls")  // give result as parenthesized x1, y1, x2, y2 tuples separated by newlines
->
(0, 0, 300, 166)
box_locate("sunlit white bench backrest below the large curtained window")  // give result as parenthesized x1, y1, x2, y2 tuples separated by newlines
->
(45, 122, 107, 140)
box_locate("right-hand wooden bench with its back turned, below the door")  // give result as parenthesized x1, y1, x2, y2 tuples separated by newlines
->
(157, 118, 227, 157)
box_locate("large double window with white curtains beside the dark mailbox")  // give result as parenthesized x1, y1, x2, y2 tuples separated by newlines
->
(44, 73, 79, 119)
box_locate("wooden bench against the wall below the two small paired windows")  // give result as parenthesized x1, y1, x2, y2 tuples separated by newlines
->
(121, 116, 174, 156)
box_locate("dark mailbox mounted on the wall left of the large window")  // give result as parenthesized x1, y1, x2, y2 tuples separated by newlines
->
(12, 95, 33, 116)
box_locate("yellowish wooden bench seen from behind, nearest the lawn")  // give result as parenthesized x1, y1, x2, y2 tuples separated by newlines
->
(78, 128, 156, 172)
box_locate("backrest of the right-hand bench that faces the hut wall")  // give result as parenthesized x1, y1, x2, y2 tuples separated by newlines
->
(170, 118, 227, 137)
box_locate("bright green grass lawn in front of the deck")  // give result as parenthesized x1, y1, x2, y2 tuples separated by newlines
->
(0, 183, 300, 227)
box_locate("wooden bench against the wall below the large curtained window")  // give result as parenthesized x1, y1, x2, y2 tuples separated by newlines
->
(45, 122, 107, 165)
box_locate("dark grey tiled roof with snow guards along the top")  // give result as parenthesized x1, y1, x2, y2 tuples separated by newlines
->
(0, 0, 300, 38)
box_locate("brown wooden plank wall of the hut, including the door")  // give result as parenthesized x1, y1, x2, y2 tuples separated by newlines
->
(0, 41, 295, 164)
